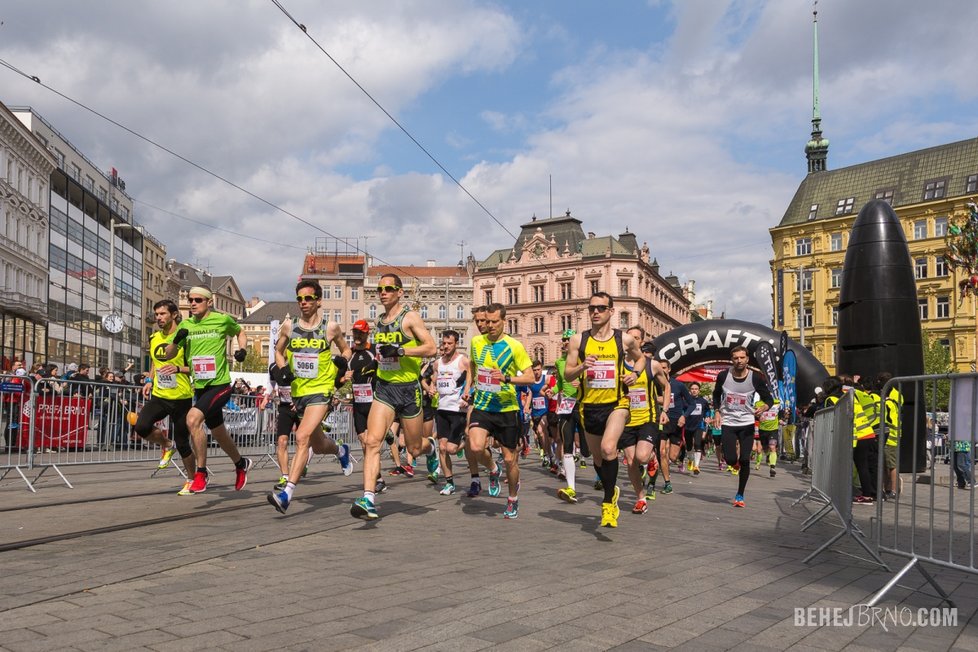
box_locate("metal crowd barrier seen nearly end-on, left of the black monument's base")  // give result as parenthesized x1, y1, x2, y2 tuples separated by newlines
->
(794, 392, 889, 570)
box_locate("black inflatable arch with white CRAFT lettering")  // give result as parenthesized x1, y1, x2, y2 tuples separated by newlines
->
(655, 319, 829, 406)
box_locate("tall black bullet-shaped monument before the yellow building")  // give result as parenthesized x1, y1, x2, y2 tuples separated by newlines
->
(837, 199, 927, 473)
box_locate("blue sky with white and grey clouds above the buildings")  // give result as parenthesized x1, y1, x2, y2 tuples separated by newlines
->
(0, 0, 978, 323)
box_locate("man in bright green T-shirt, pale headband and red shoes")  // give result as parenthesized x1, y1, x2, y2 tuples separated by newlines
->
(163, 286, 251, 493)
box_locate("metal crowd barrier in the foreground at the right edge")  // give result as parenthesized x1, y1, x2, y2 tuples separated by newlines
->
(869, 374, 978, 607)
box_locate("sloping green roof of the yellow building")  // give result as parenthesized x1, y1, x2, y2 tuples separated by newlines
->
(778, 138, 978, 226)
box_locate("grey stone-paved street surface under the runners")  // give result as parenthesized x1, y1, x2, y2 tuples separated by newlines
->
(0, 455, 978, 651)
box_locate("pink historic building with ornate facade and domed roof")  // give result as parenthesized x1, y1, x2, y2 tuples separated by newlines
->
(473, 211, 693, 364)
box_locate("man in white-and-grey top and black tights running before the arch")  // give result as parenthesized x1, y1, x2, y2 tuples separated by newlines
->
(713, 346, 773, 507)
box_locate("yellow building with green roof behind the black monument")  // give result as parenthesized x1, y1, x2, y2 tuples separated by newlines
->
(770, 138, 978, 373)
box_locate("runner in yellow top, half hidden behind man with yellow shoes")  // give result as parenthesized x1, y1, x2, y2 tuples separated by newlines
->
(618, 326, 669, 514)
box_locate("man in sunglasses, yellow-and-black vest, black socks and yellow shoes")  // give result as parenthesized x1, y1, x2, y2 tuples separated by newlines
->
(565, 292, 645, 527)
